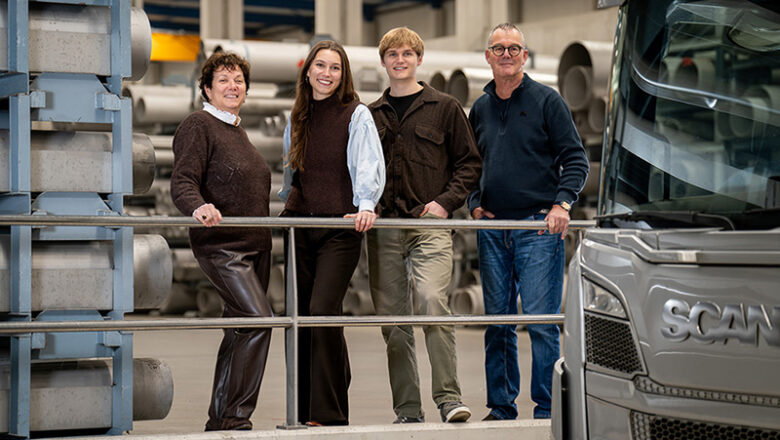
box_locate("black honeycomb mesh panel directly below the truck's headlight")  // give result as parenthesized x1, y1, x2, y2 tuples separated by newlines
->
(585, 313, 643, 374)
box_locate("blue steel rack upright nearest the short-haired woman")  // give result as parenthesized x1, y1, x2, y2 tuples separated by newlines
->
(108, 0, 133, 435)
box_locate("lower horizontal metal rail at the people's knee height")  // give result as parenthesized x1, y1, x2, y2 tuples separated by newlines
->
(0, 314, 563, 335)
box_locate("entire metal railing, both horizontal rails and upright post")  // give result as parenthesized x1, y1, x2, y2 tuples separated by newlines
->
(0, 213, 580, 427)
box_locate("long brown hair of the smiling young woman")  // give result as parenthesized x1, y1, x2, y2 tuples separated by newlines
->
(287, 40, 359, 170)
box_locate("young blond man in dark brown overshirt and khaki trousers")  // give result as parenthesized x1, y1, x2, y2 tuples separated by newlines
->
(368, 28, 481, 423)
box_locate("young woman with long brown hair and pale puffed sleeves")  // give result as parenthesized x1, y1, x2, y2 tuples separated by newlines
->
(279, 41, 385, 426)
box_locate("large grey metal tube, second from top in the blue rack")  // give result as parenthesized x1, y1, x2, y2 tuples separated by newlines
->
(0, 130, 155, 194)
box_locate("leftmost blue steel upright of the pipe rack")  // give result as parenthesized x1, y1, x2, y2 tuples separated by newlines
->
(8, 0, 32, 437)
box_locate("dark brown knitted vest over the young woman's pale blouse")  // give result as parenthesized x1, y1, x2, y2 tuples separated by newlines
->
(285, 93, 360, 216)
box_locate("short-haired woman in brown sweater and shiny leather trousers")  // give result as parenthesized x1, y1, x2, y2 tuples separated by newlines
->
(171, 52, 272, 431)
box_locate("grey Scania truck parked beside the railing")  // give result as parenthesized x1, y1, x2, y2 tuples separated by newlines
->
(552, 0, 780, 440)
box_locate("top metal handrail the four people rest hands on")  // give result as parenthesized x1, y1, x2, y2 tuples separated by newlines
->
(0, 214, 596, 229)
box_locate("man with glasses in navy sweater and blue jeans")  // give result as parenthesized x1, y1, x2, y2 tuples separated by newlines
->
(469, 23, 588, 420)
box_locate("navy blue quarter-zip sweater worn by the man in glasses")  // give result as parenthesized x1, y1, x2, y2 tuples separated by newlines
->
(468, 74, 588, 219)
